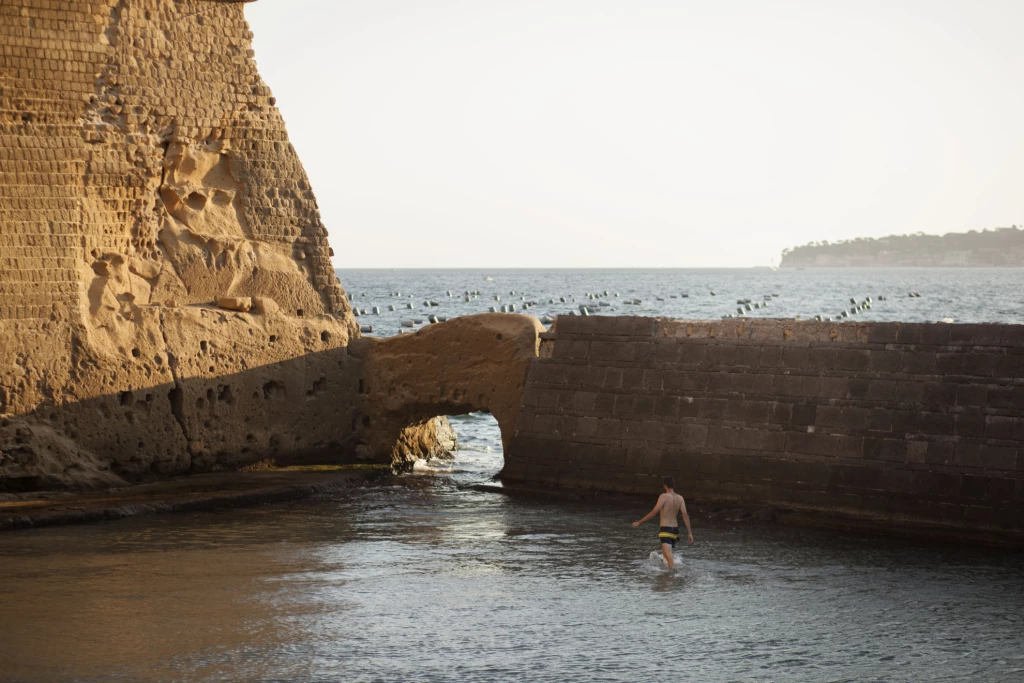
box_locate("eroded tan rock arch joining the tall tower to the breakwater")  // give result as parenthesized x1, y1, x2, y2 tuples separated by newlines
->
(349, 313, 544, 462)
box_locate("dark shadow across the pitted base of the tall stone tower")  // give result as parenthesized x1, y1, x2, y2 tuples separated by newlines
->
(0, 347, 368, 490)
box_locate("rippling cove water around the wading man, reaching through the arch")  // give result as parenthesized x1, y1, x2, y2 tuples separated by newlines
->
(0, 416, 1024, 681)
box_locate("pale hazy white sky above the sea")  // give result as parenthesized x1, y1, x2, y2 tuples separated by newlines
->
(246, 0, 1024, 267)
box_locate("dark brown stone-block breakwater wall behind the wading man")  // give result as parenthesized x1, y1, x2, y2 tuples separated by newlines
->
(502, 316, 1024, 540)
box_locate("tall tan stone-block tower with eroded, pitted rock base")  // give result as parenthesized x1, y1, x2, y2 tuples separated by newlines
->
(0, 0, 360, 485)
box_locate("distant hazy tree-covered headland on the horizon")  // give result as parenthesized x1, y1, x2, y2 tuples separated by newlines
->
(779, 225, 1024, 268)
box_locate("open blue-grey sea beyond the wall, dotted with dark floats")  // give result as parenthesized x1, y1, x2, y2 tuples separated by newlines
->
(338, 268, 1024, 336)
